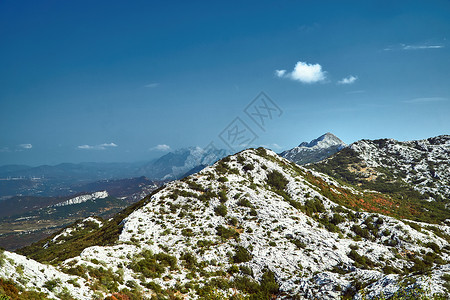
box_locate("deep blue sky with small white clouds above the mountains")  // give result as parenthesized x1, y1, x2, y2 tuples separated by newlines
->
(0, 0, 450, 165)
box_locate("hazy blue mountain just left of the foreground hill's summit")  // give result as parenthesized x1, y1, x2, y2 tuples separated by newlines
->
(138, 147, 230, 180)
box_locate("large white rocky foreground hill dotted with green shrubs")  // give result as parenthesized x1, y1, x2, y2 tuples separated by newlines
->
(4, 148, 450, 299)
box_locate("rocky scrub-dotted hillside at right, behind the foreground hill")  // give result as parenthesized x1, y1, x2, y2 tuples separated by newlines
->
(311, 135, 450, 222)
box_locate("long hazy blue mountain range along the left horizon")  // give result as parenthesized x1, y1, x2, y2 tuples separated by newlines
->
(0, 147, 230, 201)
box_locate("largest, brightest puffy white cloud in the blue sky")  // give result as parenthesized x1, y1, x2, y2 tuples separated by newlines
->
(275, 61, 326, 83)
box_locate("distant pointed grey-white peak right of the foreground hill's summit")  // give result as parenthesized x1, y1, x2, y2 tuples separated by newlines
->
(280, 132, 347, 165)
